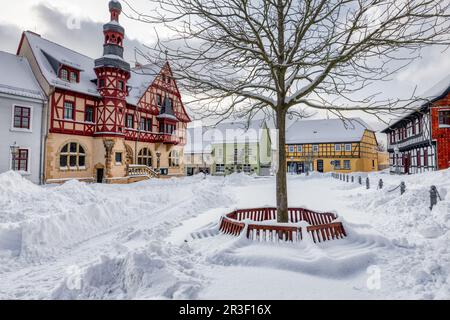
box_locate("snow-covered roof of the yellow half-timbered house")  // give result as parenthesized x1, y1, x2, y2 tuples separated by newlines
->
(286, 118, 373, 144)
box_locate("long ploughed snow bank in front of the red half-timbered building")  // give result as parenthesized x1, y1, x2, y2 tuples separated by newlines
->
(0, 173, 230, 263)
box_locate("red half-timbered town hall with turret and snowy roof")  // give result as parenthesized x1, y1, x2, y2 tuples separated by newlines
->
(17, 1, 190, 183)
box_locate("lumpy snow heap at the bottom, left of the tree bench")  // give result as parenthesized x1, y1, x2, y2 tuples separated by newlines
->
(52, 241, 202, 299)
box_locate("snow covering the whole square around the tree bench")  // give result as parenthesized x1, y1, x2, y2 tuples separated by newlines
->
(0, 170, 450, 299)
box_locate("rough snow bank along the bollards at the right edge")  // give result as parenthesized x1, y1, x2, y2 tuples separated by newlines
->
(349, 170, 450, 299)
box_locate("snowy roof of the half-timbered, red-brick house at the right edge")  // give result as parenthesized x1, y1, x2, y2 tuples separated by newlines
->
(381, 75, 450, 133)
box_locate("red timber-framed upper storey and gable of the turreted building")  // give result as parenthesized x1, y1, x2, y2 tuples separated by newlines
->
(49, 64, 191, 145)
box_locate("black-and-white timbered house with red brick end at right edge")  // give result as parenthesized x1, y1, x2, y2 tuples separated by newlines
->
(383, 77, 450, 174)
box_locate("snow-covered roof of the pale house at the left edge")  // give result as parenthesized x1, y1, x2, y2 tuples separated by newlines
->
(0, 51, 45, 100)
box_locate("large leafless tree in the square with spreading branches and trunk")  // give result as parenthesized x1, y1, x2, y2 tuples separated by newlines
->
(121, 0, 450, 222)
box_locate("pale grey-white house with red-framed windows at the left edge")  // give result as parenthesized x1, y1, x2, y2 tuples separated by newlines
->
(0, 52, 45, 183)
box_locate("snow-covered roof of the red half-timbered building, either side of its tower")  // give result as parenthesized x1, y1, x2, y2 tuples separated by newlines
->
(25, 31, 160, 105)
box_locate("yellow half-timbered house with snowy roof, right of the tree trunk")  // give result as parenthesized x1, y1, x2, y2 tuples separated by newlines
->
(286, 118, 378, 174)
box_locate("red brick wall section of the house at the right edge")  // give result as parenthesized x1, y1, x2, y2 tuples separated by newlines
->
(431, 93, 450, 170)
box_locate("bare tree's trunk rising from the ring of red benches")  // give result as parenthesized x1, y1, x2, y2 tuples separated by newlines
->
(277, 110, 289, 222)
